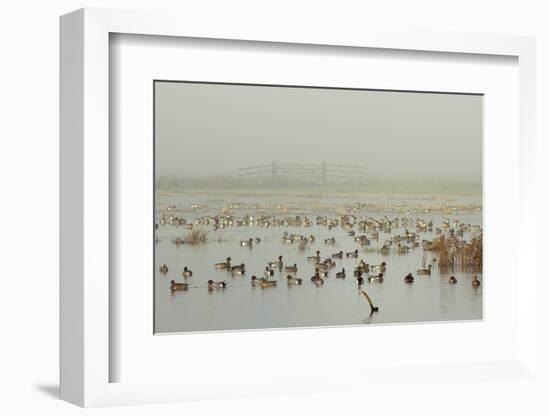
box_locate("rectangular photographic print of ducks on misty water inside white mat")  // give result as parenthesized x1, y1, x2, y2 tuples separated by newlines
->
(153, 81, 483, 334)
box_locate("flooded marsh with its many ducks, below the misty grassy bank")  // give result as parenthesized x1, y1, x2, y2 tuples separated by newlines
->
(154, 190, 483, 333)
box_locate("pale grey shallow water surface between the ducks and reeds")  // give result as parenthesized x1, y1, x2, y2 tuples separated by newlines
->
(155, 191, 483, 333)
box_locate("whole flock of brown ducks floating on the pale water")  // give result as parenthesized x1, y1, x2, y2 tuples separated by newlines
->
(157, 208, 481, 316)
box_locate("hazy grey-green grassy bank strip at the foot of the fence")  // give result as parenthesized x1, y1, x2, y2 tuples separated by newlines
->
(156, 176, 482, 195)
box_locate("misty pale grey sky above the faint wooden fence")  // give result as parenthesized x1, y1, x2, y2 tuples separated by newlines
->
(155, 82, 482, 182)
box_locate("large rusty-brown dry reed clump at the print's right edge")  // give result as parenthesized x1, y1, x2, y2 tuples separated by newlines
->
(429, 236, 483, 271)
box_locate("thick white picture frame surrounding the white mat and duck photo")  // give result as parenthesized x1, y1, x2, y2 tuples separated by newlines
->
(60, 9, 537, 406)
